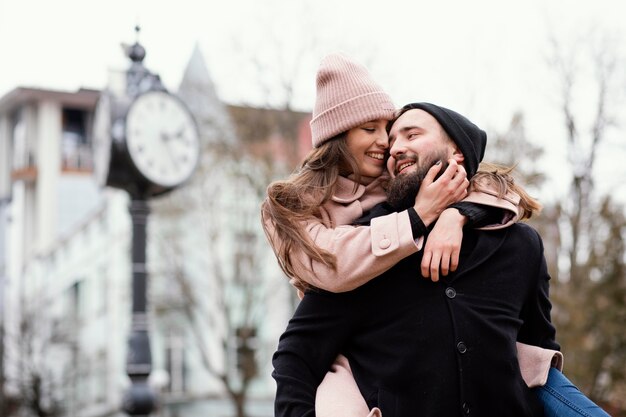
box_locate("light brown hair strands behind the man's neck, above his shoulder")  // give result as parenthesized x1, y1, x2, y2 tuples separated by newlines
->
(470, 162, 542, 220)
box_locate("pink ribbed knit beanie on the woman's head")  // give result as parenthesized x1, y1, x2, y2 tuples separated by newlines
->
(311, 54, 395, 147)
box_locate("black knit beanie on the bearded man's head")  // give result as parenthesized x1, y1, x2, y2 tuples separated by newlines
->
(394, 103, 487, 178)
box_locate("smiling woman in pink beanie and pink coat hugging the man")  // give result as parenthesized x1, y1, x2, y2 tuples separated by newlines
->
(262, 55, 604, 416)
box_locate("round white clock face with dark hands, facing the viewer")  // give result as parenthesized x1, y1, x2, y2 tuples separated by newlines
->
(126, 91, 200, 187)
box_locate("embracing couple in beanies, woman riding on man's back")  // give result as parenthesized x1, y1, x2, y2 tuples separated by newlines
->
(262, 55, 606, 417)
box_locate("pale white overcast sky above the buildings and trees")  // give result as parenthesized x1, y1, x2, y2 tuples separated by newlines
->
(0, 0, 626, 200)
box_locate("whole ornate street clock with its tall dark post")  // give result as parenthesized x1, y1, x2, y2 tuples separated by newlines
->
(94, 28, 200, 416)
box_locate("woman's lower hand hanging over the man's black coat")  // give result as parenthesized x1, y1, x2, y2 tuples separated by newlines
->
(422, 208, 467, 282)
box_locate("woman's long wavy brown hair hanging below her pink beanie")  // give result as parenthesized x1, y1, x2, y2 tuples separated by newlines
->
(261, 133, 360, 286)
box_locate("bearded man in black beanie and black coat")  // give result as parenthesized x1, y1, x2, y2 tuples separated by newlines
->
(273, 103, 559, 417)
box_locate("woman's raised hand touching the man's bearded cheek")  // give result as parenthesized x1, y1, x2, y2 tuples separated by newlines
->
(413, 159, 469, 227)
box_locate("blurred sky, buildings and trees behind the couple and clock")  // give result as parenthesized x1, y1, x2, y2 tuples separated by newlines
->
(0, 0, 626, 417)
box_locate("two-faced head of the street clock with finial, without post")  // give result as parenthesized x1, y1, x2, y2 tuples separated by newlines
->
(93, 39, 200, 198)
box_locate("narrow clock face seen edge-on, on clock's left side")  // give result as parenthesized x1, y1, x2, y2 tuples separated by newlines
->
(93, 91, 111, 186)
